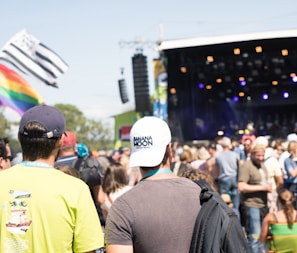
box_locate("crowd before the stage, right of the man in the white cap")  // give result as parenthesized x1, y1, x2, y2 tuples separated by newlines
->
(172, 133, 297, 253)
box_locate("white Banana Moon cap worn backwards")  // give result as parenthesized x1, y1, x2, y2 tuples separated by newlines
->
(130, 116, 171, 167)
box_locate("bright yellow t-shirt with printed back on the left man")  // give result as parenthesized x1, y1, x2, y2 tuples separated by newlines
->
(0, 164, 104, 253)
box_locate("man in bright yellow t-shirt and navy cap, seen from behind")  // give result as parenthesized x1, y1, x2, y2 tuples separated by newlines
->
(0, 105, 104, 253)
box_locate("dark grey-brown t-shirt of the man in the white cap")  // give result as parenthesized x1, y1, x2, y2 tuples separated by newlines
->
(105, 178, 200, 253)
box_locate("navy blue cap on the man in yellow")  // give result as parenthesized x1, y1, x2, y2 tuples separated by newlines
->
(19, 105, 66, 139)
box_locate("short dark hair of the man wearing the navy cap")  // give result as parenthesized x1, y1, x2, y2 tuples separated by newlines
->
(19, 122, 61, 161)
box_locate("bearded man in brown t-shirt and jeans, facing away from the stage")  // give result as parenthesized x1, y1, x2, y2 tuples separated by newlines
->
(238, 145, 272, 253)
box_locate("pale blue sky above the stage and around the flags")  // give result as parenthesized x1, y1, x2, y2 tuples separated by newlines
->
(0, 0, 297, 122)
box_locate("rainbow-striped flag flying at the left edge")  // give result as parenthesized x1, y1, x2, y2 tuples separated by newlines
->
(0, 64, 43, 115)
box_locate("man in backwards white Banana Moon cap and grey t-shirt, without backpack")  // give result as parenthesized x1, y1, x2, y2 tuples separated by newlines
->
(105, 116, 201, 253)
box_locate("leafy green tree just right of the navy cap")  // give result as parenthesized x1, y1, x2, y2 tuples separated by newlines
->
(54, 104, 114, 150)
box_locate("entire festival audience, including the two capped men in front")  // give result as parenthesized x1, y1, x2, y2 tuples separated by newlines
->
(0, 105, 297, 253)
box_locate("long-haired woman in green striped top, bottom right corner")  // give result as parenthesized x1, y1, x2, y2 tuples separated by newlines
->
(259, 189, 297, 253)
